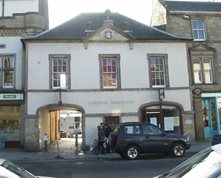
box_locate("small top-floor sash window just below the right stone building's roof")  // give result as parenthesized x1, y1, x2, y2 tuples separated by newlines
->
(192, 20, 206, 41)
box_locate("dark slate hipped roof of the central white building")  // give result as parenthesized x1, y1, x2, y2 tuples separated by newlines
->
(23, 10, 190, 40)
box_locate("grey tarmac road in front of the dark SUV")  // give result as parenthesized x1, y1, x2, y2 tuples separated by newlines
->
(16, 155, 189, 178)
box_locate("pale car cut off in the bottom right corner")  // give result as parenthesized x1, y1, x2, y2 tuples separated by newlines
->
(155, 144, 221, 178)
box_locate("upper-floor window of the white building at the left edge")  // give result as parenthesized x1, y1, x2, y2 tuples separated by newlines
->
(0, 55, 15, 88)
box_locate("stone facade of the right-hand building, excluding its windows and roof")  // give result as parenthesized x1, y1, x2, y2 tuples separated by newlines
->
(151, 0, 221, 139)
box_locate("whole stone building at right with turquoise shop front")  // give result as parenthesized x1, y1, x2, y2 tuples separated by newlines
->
(151, 0, 221, 139)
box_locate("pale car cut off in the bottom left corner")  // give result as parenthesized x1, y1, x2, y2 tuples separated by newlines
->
(0, 158, 52, 178)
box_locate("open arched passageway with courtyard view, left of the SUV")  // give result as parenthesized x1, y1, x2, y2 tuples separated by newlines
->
(37, 104, 85, 149)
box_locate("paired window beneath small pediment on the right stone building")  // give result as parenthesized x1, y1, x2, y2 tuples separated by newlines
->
(192, 57, 213, 84)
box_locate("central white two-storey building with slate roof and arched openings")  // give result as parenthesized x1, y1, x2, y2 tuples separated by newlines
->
(23, 10, 195, 150)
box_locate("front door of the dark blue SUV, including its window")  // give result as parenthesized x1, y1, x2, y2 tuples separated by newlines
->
(142, 124, 168, 153)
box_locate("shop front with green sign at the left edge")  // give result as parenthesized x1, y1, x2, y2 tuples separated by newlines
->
(0, 93, 24, 148)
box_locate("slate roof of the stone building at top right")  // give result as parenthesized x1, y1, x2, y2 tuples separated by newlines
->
(164, 1, 221, 12)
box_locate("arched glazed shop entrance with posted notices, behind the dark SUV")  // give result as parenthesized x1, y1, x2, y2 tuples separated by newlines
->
(139, 101, 183, 134)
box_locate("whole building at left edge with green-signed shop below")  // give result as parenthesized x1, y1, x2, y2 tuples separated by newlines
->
(0, 0, 48, 147)
